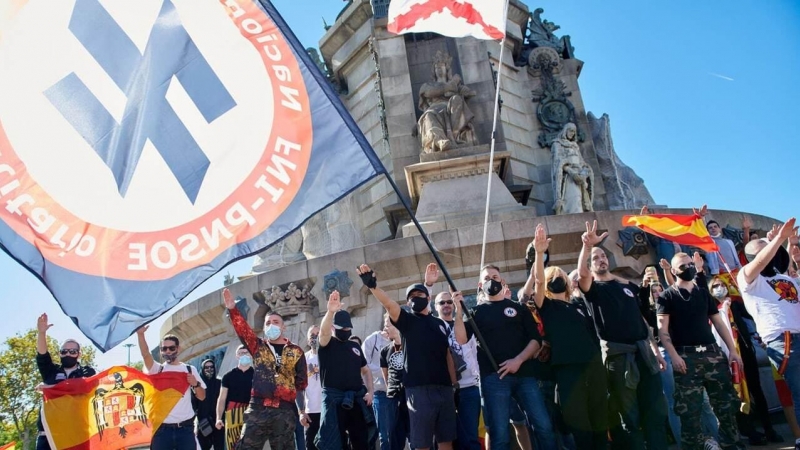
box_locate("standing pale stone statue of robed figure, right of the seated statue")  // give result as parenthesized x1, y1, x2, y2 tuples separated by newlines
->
(550, 123, 594, 214)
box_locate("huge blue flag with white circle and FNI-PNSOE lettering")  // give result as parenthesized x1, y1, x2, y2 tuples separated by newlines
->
(0, 0, 384, 350)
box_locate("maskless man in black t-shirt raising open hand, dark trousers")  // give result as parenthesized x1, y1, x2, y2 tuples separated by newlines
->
(578, 220, 667, 450)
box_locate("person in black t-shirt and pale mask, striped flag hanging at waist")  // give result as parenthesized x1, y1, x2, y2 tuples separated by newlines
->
(216, 345, 255, 449)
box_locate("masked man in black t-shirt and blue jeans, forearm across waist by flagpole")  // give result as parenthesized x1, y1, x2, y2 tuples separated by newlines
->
(474, 265, 557, 450)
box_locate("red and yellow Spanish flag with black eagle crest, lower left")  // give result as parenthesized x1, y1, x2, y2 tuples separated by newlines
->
(42, 366, 189, 450)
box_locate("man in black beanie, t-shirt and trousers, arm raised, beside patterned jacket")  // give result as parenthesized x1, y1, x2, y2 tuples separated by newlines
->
(315, 291, 378, 450)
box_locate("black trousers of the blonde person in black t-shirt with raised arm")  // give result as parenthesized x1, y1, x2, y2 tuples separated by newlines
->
(553, 355, 608, 450)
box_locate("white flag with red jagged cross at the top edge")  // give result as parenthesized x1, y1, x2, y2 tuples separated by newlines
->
(387, 0, 506, 40)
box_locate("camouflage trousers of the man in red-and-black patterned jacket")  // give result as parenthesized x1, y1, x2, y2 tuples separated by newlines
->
(236, 402, 297, 450)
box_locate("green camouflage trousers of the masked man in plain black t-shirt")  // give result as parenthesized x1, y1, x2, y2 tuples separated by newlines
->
(674, 346, 745, 450)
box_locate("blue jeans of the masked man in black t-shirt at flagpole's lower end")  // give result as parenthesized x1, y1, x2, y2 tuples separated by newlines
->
(481, 373, 557, 450)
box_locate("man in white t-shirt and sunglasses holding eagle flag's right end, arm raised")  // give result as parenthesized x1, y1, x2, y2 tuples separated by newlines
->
(136, 325, 206, 450)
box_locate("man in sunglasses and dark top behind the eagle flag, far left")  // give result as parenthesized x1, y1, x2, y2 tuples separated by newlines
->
(36, 314, 96, 450)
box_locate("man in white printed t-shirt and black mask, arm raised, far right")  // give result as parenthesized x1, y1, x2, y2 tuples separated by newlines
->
(736, 218, 800, 449)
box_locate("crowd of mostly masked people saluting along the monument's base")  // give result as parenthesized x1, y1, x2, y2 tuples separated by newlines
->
(37, 210, 800, 450)
